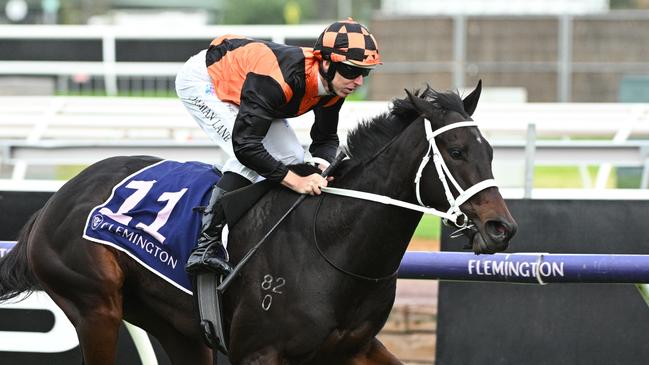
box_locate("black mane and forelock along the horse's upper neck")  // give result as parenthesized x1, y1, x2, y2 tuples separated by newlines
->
(346, 85, 468, 161)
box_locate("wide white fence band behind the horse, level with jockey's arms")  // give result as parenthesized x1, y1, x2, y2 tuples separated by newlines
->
(0, 97, 649, 187)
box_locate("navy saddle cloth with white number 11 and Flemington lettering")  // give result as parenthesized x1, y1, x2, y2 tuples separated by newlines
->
(83, 160, 220, 294)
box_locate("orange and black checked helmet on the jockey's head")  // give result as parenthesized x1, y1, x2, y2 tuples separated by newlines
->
(313, 18, 381, 68)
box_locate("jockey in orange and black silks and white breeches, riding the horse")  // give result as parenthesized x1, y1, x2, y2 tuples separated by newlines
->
(176, 18, 381, 276)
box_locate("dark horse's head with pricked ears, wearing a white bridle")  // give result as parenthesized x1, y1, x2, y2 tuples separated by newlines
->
(406, 82, 517, 253)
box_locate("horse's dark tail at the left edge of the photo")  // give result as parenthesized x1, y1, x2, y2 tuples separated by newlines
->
(0, 211, 40, 302)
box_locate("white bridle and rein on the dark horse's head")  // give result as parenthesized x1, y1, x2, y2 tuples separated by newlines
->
(322, 118, 498, 228)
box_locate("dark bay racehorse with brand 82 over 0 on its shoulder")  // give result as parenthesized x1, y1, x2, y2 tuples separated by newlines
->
(0, 84, 516, 365)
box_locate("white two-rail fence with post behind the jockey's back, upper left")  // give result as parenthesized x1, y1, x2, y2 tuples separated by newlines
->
(0, 24, 326, 95)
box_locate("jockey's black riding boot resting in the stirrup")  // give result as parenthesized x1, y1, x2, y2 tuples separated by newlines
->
(185, 186, 232, 277)
